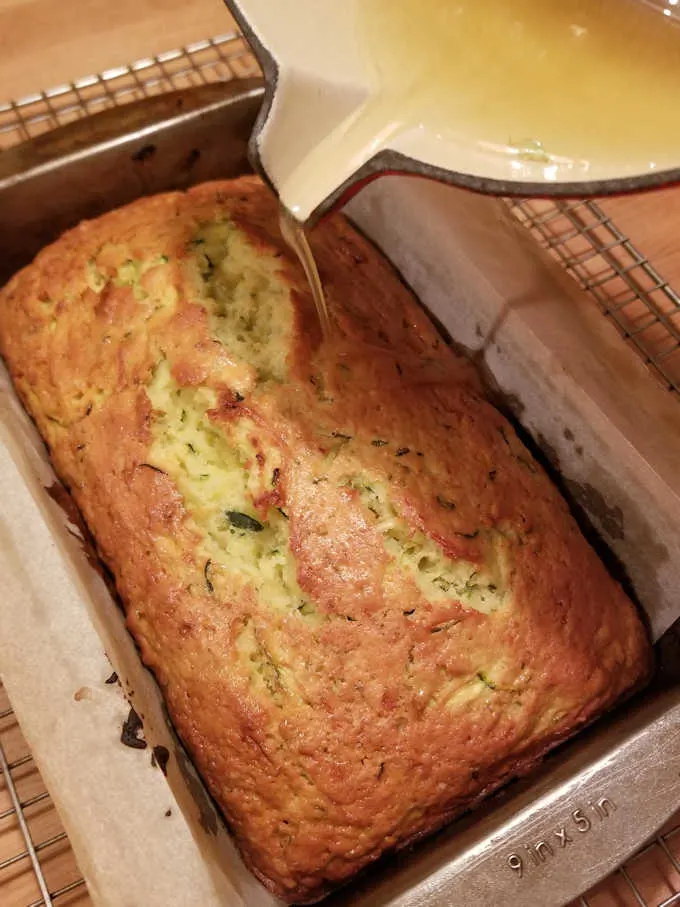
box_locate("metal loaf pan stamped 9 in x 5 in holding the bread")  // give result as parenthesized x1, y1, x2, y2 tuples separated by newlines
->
(0, 80, 680, 907)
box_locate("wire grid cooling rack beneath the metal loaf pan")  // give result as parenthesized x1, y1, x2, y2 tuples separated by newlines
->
(0, 24, 680, 907)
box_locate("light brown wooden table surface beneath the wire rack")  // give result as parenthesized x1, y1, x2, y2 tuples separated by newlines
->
(0, 0, 680, 907)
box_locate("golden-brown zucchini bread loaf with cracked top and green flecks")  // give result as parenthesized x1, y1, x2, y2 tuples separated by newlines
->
(0, 177, 651, 902)
